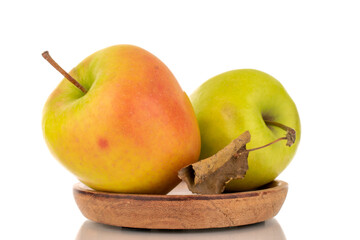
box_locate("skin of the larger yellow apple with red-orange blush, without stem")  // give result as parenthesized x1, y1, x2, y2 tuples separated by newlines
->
(42, 45, 201, 194)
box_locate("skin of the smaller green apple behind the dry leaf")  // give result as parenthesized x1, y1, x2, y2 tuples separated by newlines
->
(190, 69, 301, 191)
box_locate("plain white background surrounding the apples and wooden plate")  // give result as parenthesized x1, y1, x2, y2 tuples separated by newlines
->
(0, 0, 360, 239)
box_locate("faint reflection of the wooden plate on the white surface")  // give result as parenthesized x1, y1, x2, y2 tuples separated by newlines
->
(76, 218, 286, 240)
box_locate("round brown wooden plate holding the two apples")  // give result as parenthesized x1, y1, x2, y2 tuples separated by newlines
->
(73, 180, 288, 229)
